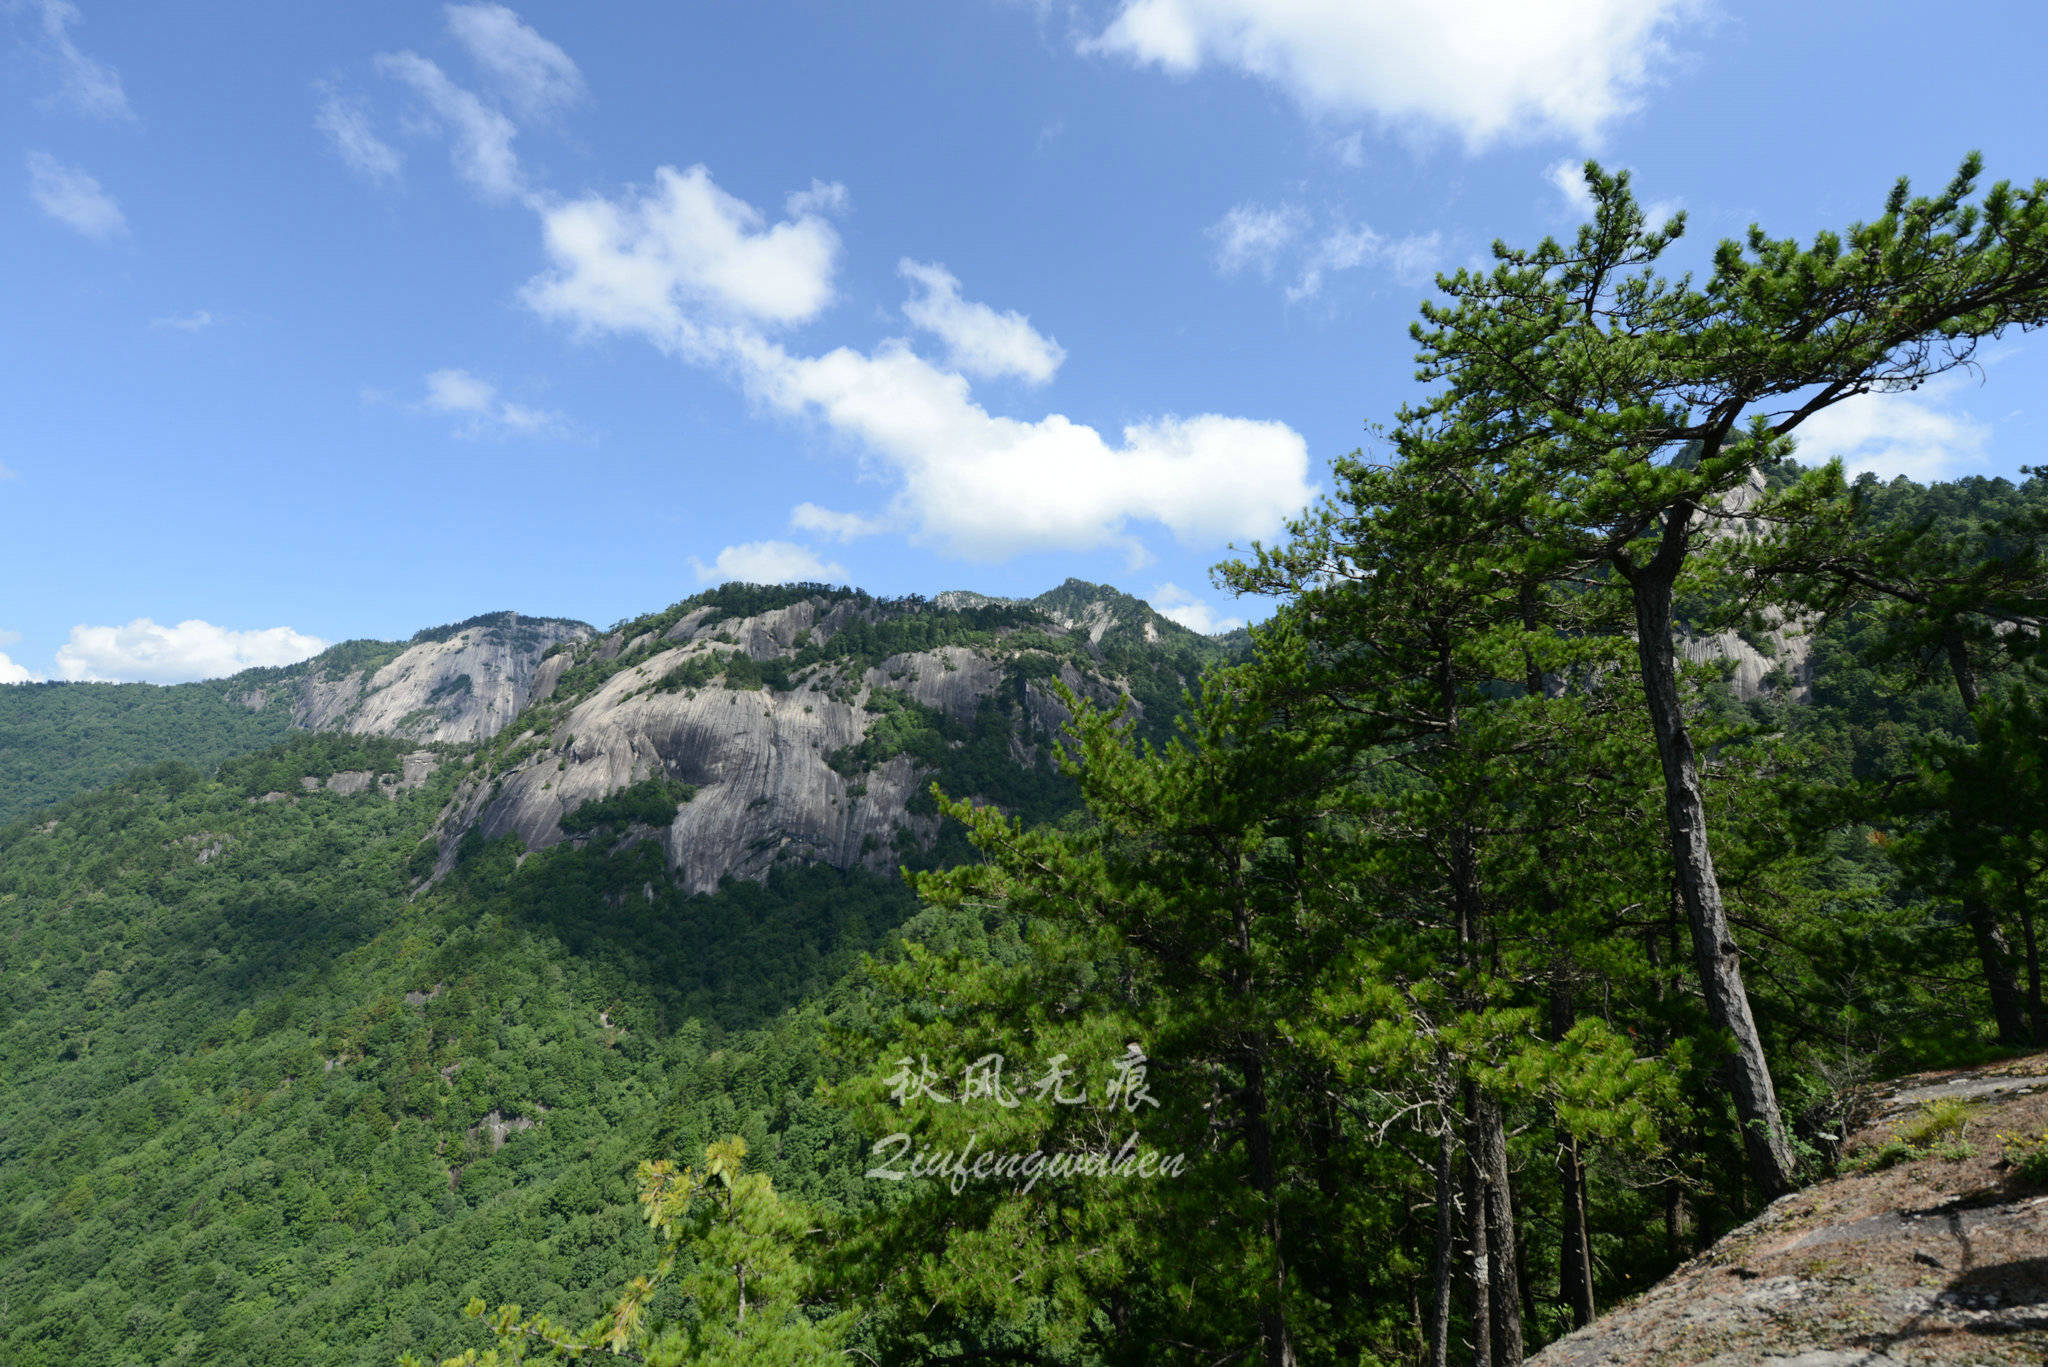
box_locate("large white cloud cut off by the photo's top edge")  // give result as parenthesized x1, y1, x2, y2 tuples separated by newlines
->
(1081, 0, 1700, 148)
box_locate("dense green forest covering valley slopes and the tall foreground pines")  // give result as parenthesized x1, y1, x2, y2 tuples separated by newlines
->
(0, 164, 2048, 1367)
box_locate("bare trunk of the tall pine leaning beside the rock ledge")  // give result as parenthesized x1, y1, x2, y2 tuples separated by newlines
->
(1628, 557, 1792, 1199)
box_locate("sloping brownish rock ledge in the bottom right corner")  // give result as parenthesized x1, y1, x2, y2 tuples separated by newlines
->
(1530, 1055, 2048, 1367)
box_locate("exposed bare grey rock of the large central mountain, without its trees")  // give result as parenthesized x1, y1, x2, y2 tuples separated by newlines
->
(438, 598, 1196, 892)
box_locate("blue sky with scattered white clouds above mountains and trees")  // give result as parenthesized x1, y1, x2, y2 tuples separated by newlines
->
(0, 0, 2048, 680)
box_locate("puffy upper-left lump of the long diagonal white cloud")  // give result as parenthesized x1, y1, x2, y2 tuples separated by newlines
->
(524, 166, 840, 340)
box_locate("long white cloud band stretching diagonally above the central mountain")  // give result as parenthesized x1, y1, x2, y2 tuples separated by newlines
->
(524, 166, 1315, 560)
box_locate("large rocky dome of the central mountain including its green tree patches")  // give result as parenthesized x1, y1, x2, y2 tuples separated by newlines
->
(438, 584, 1221, 892)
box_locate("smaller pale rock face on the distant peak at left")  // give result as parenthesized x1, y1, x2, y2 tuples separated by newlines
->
(293, 613, 592, 742)
